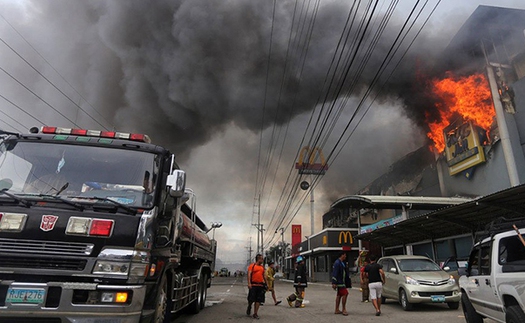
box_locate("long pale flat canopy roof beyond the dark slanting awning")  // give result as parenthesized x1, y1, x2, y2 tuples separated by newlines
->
(330, 195, 472, 210)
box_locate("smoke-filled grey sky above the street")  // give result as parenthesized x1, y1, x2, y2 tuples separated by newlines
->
(0, 0, 525, 269)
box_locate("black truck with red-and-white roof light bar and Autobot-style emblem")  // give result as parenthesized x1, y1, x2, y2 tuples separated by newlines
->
(0, 127, 216, 323)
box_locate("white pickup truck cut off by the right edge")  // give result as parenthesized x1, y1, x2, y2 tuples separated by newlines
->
(459, 224, 525, 323)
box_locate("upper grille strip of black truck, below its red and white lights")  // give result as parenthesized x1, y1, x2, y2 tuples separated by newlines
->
(0, 238, 94, 256)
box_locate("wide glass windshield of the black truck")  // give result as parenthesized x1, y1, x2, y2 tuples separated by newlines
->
(0, 141, 158, 208)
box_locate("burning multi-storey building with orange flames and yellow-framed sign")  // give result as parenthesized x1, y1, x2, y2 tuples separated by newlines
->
(323, 6, 525, 261)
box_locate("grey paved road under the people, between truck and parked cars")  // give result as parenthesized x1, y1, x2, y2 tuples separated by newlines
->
(173, 277, 492, 323)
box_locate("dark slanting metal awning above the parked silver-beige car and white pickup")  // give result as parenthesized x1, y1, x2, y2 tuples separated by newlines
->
(356, 184, 525, 247)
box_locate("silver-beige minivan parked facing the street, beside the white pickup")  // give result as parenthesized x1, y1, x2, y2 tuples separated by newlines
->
(378, 255, 461, 311)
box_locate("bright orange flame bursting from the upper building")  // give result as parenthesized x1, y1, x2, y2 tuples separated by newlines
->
(427, 72, 496, 152)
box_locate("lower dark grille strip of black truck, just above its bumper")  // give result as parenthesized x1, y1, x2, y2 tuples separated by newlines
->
(0, 255, 87, 271)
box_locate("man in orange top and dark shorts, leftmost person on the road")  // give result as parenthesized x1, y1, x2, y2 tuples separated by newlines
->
(246, 254, 267, 319)
